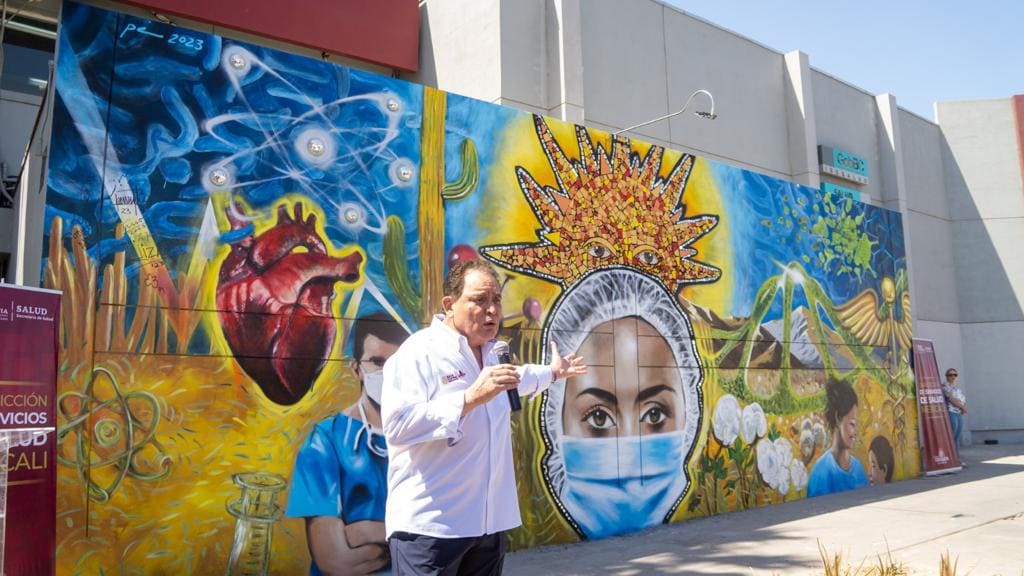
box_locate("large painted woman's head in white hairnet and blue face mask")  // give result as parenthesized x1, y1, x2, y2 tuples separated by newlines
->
(542, 269, 701, 539)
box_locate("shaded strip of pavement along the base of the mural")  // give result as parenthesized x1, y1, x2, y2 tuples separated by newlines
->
(505, 444, 1024, 576)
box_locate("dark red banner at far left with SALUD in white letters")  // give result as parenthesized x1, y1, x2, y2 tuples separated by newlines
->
(0, 284, 60, 576)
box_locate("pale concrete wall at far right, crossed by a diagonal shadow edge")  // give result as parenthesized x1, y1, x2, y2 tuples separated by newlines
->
(936, 99, 1024, 441)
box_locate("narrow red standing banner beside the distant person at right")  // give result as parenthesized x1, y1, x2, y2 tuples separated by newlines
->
(913, 338, 961, 476)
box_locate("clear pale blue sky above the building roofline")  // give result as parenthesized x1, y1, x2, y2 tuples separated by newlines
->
(665, 0, 1024, 119)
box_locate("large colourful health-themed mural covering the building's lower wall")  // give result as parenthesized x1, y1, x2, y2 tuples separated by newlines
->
(43, 3, 920, 574)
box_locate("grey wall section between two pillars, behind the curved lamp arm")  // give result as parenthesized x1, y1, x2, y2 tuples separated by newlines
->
(581, 0, 792, 177)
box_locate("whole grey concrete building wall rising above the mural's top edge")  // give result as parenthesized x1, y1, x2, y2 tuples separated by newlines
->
(423, 0, 913, 188)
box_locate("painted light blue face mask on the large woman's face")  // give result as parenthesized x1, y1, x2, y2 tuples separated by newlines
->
(561, 431, 687, 539)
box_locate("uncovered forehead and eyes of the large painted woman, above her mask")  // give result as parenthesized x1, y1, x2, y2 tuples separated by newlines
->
(562, 317, 685, 438)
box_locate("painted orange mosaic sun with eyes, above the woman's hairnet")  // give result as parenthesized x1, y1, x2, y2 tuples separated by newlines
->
(480, 116, 721, 292)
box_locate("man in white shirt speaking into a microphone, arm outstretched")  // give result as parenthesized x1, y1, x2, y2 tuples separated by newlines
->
(381, 259, 587, 576)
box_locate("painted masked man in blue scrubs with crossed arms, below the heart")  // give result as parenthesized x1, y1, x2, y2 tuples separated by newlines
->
(286, 314, 408, 575)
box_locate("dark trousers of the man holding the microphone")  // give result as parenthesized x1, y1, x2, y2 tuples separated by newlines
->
(388, 532, 506, 576)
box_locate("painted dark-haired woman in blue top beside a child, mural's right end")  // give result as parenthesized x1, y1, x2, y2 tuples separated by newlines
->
(807, 380, 867, 497)
